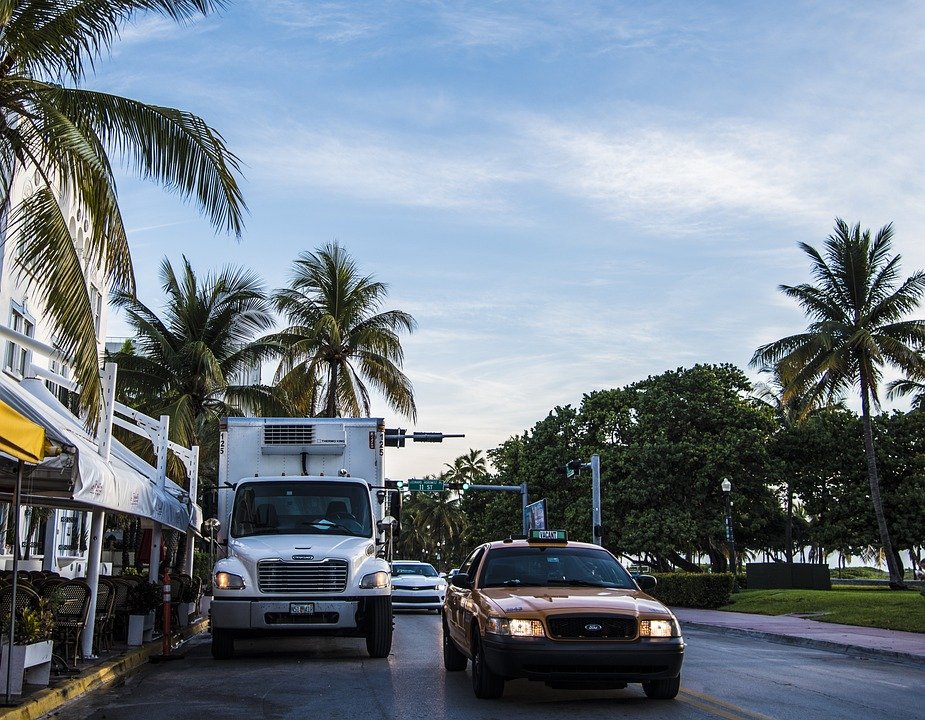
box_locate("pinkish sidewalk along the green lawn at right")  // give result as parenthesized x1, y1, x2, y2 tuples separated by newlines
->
(672, 608, 925, 665)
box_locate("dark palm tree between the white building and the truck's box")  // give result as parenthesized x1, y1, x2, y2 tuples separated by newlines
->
(111, 257, 280, 472)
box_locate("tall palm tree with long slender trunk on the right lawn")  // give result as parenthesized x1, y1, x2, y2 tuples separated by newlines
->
(751, 219, 925, 588)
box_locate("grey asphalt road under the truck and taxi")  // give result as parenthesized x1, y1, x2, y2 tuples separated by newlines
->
(54, 614, 925, 720)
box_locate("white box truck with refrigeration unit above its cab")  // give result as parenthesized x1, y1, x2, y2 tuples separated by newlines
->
(211, 417, 404, 659)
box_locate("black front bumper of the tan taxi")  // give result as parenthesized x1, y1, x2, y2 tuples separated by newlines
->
(482, 635, 684, 682)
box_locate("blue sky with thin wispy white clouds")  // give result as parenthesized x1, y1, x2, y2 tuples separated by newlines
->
(94, 0, 925, 479)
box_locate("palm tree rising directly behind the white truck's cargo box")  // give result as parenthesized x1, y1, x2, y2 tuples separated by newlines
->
(274, 242, 417, 420)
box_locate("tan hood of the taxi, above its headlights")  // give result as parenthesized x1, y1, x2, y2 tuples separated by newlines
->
(481, 587, 671, 616)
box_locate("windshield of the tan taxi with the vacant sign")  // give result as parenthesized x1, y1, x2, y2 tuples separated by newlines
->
(479, 546, 636, 590)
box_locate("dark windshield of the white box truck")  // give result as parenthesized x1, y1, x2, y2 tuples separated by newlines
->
(231, 480, 373, 538)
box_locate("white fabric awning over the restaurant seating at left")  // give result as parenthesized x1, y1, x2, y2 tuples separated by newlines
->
(0, 374, 202, 532)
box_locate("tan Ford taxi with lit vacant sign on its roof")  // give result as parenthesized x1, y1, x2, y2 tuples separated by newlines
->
(443, 530, 684, 699)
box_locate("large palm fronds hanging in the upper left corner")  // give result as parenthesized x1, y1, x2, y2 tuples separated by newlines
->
(0, 0, 244, 421)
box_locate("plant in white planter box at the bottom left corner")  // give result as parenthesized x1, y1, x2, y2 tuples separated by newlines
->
(0, 597, 55, 695)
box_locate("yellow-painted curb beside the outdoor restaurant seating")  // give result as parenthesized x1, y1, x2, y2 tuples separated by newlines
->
(0, 619, 209, 720)
